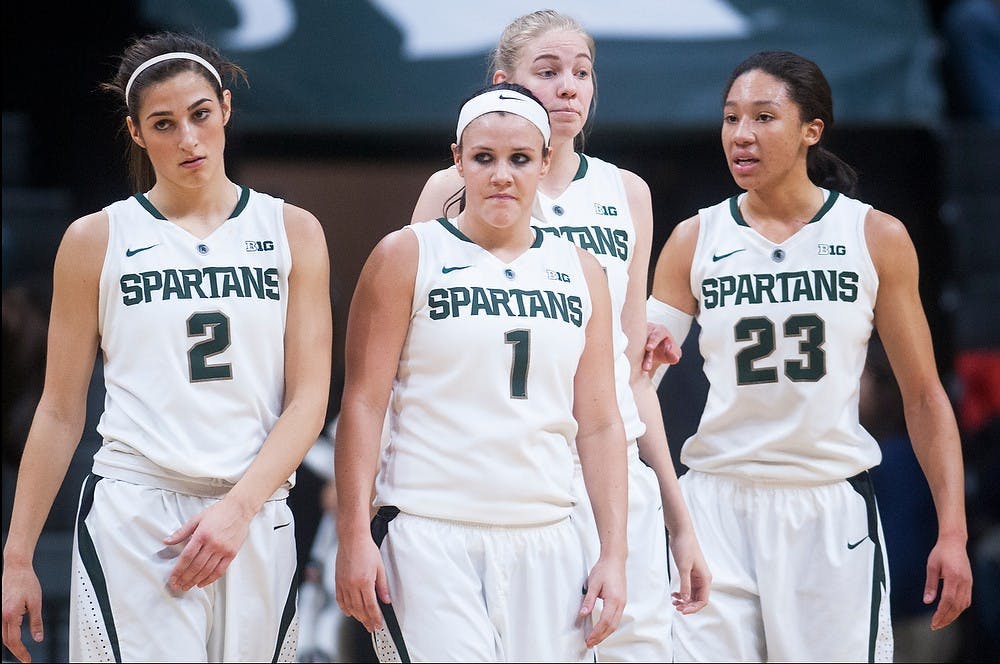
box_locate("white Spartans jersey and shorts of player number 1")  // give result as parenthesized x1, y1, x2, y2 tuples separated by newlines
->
(372, 219, 591, 662)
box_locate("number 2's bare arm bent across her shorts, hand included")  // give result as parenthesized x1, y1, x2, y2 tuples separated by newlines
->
(165, 204, 333, 590)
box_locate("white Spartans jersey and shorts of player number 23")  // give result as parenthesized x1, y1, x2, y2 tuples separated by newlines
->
(674, 191, 892, 661)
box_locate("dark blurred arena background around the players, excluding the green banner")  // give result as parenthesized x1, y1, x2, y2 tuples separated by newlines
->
(2, 1, 1000, 661)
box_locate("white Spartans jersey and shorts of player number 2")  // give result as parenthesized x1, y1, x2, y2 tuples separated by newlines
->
(70, 188, 296, 661)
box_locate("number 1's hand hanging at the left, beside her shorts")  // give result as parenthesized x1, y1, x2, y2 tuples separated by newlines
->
(336, 537, 390, 632)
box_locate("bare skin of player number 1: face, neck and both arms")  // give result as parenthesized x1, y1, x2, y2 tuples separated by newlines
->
(334, 113, 627, 647)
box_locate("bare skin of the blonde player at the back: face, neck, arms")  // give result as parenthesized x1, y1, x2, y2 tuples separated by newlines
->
(411, 30, 711, 613)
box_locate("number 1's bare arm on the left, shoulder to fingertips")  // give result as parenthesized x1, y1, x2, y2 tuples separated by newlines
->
(334, 229, 419, 631)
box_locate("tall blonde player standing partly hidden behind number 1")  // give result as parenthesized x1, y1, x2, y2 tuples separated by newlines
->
(413, 10, 710, 662)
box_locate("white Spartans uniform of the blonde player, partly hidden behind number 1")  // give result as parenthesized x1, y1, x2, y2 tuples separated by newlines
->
(534, 154, 674, 662)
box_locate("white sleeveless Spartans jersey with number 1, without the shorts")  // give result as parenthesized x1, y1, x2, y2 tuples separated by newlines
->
(375, 219, 591, 525)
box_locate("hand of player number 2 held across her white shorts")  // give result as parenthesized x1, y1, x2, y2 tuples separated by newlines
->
(163, 498, 253, 591)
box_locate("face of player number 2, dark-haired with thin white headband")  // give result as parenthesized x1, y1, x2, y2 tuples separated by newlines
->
(127, 71, 230, 187)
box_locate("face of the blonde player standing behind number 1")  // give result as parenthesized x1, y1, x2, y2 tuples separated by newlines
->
(493, 30, 594, 143)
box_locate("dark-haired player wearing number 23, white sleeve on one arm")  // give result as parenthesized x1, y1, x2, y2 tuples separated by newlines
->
(649, 52, 972, 662)
